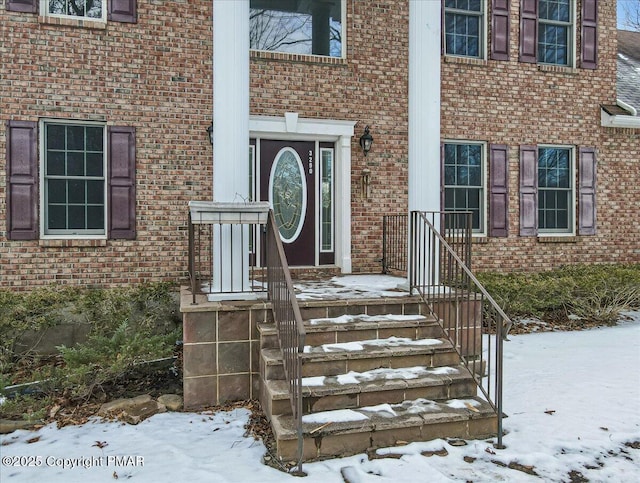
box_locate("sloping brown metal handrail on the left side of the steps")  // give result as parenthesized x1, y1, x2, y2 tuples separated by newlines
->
(266, 210, 306, 473)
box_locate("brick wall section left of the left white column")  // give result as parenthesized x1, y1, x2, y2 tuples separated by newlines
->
(0, 0, 212, 287)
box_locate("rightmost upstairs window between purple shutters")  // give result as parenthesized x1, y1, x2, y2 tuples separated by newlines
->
(538, 0, 573, 65)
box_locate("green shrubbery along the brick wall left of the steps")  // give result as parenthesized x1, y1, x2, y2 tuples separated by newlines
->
(0, 283, 181, 419)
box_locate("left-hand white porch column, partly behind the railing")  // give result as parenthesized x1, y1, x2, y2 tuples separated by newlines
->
(213, 0, 249, 292)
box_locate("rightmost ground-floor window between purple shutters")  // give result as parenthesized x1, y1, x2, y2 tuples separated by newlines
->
(538, 146, 575, 234)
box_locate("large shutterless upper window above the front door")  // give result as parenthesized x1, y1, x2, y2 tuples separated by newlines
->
(249, 0, 345, 57)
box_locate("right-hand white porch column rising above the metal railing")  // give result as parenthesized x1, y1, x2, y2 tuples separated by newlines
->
(409, 0, 441, 288)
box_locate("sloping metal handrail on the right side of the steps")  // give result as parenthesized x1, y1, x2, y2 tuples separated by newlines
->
(409, 211, 511, 448)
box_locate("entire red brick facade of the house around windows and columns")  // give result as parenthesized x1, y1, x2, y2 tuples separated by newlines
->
(0, 0, 640, 288)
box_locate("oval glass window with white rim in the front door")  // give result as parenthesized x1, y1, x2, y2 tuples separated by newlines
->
(269, 148, 307, 243)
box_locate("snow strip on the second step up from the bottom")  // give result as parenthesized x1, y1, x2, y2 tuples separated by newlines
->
(302, 366, 460, 387)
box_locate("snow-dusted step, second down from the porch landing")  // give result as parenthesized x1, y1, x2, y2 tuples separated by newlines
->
(260, 337, 460, 380)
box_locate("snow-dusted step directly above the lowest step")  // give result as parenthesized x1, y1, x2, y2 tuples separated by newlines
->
(262, 365, 477, 415)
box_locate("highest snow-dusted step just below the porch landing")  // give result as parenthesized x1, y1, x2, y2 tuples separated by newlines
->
(258, 314, 443, 349)
